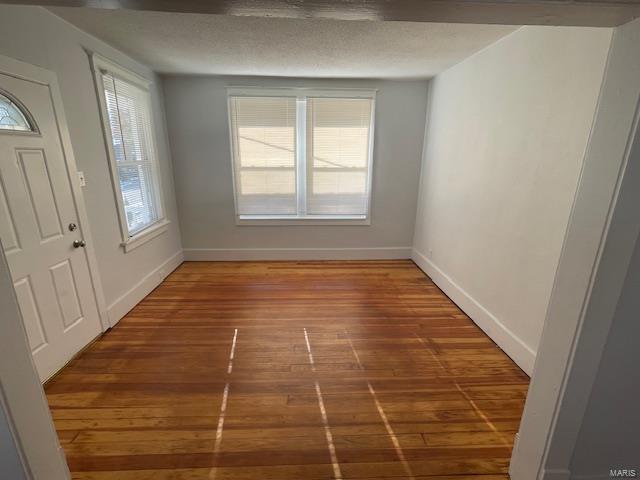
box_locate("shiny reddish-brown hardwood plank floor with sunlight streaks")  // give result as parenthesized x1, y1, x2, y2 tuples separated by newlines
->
(46, 260, 529, 480)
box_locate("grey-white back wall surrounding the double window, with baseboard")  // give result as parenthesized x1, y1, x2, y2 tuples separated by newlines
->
(164, 76, 427, 260)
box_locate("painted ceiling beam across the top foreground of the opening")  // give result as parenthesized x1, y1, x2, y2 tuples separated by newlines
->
(0, 0, 640, 27)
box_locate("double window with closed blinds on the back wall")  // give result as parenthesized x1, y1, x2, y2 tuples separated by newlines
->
(229, 89, 374, 220)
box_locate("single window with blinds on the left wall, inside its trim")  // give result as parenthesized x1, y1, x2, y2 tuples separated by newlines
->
(100, 66, 162, 237)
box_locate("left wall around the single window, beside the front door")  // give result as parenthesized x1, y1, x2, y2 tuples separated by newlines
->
(0, 5, 181, 319)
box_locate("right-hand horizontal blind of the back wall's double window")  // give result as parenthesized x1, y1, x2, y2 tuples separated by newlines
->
(307, 98, 372, 215)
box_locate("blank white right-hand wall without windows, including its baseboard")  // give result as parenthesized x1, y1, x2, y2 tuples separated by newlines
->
(414, 27, 611, 374)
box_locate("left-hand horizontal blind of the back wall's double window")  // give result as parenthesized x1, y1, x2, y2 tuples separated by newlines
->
(229, 97, 297, 215)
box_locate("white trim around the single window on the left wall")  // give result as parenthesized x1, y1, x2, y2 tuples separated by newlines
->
(89, 52, 171, 253)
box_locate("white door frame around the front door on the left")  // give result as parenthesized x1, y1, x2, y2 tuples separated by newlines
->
(0, 51, 111, 332)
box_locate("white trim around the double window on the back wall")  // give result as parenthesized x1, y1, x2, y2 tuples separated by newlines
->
(227, 87, 378, 226)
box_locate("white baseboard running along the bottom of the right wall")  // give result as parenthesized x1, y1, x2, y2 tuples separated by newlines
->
(411, 249, 536, 376)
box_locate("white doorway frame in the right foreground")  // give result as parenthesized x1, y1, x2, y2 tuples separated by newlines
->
(510, 15, 640, 480)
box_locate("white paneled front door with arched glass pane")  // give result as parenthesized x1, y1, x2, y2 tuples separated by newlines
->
(0, 73, 101, 380)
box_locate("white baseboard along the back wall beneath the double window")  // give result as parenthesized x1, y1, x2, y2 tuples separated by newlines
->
(184, 247, 411, 261)
